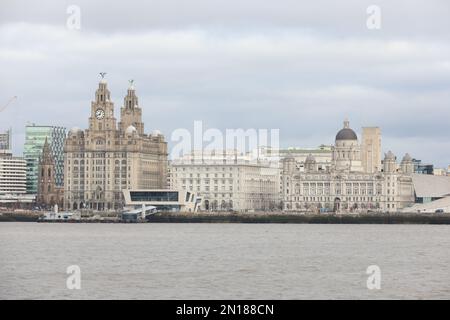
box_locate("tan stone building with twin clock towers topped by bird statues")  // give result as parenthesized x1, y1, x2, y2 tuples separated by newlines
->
(64, 79, 167, 210)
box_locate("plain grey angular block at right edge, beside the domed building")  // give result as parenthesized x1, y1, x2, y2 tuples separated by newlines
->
(412, 173, 450, 198)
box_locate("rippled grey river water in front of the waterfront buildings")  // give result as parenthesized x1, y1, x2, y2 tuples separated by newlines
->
(0, 222, 450, 299)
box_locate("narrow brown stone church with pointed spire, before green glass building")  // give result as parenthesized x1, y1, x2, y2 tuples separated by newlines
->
(36, 139, 64, 208)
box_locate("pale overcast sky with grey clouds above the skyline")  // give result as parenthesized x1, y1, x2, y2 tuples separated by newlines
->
(0, 0, 450, 167)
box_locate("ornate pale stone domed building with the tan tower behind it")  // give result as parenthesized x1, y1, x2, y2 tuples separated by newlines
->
(281, 121, 414, 212)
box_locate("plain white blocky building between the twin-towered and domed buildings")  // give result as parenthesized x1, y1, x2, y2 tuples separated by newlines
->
(170, 150, 280, 211)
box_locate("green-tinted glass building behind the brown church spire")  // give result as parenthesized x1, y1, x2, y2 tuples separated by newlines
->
(23, 124, 66, 194)
